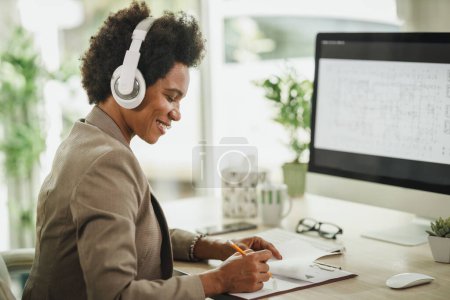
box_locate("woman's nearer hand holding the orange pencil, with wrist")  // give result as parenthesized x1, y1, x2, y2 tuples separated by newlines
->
(200, 250, 272, 297)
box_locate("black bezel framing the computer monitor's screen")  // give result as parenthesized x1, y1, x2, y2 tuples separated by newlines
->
(308, 32, 450, 195)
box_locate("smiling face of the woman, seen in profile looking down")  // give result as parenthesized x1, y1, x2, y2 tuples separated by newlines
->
(121, 63, 189, 144)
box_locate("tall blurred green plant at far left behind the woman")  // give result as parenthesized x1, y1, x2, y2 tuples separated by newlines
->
(0, 28, 45, 247)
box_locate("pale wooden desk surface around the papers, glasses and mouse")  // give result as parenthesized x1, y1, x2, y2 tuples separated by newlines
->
(162, 195, 450, 300)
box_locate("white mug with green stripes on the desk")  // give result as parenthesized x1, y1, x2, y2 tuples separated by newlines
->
(258, 184, 292, 226)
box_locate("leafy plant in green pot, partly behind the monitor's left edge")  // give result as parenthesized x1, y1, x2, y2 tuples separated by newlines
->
(256, 68, 313, 197)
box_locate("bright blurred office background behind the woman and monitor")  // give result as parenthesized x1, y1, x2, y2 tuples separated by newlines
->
(0, 0, 450, 251)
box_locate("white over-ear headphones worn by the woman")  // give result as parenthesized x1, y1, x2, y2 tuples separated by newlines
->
(111, 17, 154, 109)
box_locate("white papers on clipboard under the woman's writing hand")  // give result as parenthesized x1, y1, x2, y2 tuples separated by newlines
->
(231, 229, 356, 299)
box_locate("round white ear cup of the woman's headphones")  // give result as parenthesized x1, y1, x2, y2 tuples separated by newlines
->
(110, 66, 147, 109)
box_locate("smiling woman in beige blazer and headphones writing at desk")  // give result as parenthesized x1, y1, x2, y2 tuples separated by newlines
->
(23, 2, 281, 300)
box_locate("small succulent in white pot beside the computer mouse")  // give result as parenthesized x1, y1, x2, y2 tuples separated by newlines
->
(427, 217, 450, 264)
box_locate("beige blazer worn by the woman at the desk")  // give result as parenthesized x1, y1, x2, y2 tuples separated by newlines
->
(23, 107, 205, 300)
